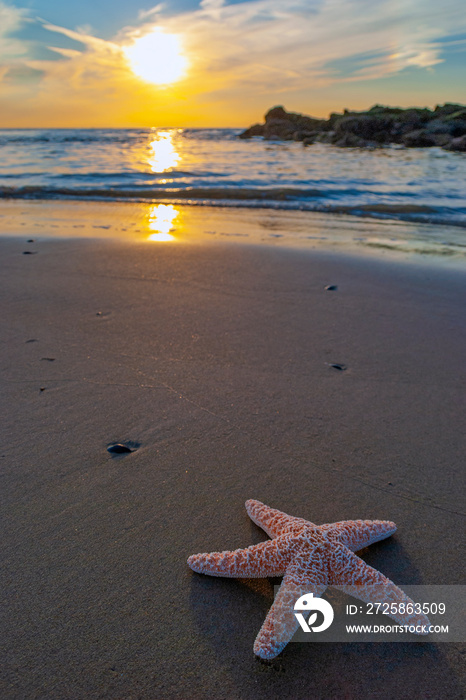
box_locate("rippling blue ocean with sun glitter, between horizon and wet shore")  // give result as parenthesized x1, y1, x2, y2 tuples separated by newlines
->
(0, 128, 466, 254)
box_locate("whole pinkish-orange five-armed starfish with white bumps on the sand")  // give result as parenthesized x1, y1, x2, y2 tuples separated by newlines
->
(188, 500, 430, 659)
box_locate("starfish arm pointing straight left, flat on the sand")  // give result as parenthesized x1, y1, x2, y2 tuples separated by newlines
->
(188, 540, 290, 578)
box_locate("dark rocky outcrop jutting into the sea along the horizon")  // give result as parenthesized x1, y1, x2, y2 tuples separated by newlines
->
(239, 104, 466, 151)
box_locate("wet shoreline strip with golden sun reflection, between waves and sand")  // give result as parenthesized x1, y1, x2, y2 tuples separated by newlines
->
(0, 200, 466, 269)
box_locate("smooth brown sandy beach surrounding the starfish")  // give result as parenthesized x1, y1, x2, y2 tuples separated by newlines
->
(0, 217, 466, 700)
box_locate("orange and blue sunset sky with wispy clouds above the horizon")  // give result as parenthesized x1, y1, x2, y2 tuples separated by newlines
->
(0, 0, 466, 127)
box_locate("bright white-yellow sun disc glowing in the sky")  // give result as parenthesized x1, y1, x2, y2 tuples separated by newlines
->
(123, 28, 187, 85)
